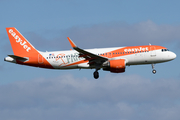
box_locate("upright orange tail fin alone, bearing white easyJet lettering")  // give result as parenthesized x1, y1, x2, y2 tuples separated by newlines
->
(6, 27, 37, 57)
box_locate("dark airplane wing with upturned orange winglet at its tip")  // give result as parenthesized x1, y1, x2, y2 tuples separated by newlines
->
(67, 37, 108, 64)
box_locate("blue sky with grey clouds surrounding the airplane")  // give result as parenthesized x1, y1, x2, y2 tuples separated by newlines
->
(0, 0, 180, 120)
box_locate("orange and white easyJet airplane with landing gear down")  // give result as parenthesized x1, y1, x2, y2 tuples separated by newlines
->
(4, 27, 176, 79)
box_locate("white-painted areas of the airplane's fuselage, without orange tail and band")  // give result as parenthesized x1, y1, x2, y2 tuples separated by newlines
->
(39, 47, 176, 69)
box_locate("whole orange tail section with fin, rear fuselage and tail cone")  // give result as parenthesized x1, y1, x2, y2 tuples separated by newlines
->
(4, 27, 53, 69)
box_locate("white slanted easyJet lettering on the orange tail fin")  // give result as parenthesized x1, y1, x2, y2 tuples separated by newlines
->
(9, 29, 31, 52)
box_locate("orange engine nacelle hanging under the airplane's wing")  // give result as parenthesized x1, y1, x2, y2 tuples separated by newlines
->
(103, 59, 126, 73)
